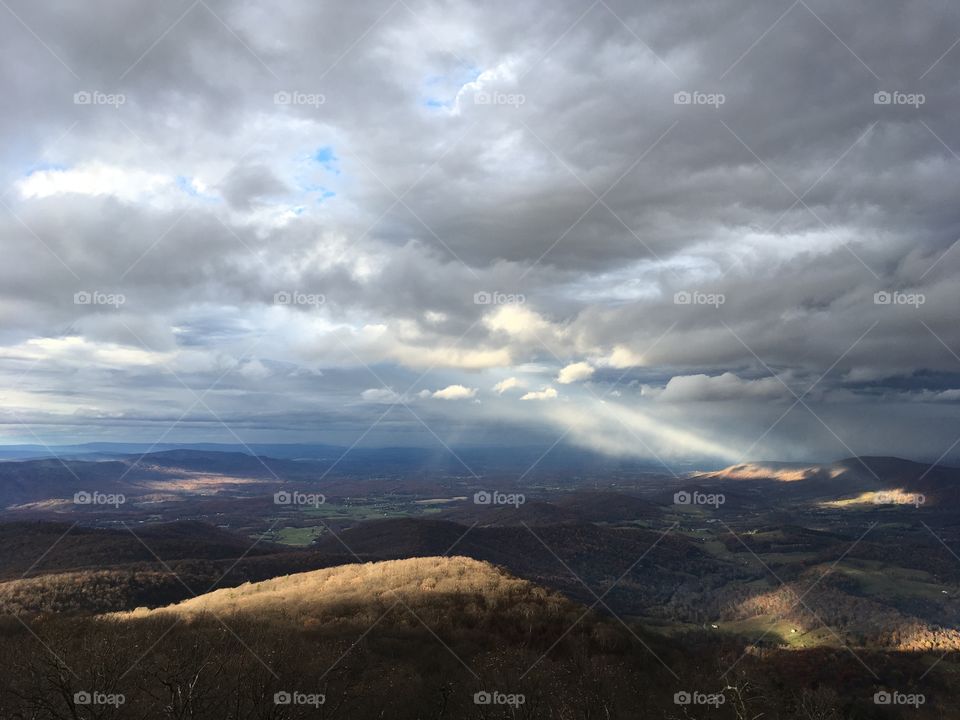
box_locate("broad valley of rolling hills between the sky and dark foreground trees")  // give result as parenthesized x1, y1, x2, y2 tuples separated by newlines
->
(0, 450, 960, 717)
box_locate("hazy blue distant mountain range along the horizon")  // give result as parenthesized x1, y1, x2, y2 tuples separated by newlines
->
(0, 445, 948, 512)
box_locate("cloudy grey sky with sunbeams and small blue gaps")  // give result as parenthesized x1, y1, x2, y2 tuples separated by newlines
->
(0, 0, 960, 463)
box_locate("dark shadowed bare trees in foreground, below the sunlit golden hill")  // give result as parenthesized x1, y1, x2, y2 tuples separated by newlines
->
(0, 607, 952, 720)
